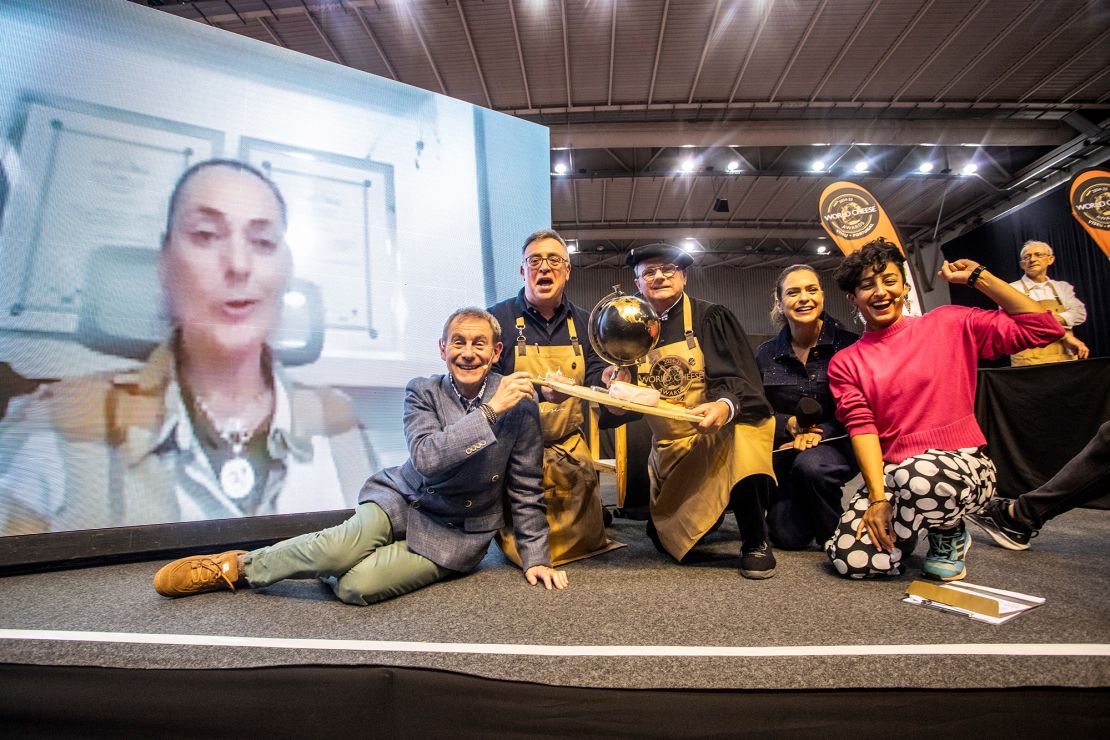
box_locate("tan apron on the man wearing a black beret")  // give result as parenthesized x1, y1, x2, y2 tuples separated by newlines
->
(637, 294, 775, 560)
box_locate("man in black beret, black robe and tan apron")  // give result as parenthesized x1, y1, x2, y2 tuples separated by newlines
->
(627, 244, 775, 579)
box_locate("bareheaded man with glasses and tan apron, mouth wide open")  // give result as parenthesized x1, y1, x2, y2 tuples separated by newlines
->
(490, 229, 623, 565)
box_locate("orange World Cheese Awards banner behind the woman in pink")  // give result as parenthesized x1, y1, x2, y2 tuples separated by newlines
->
(818, 180, 924, 316)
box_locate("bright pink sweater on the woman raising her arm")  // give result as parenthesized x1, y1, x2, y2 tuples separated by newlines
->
(829, 306, 1063, 463)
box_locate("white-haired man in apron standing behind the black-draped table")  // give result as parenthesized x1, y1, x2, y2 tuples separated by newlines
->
(1010, 240, 1089, 365)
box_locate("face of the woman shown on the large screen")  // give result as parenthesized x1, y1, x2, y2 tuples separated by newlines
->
(161, 165, 292, 357)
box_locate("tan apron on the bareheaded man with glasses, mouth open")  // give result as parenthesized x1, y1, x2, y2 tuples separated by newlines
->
(497, 316, 623, 566)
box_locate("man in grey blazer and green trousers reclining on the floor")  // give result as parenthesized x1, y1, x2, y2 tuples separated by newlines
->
(154, 308, 567, 606)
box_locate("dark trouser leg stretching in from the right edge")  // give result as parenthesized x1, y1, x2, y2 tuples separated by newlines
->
(1013, 420, 1110, 529)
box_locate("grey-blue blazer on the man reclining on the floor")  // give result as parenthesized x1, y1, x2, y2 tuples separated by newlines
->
(359, 373, 551, 571)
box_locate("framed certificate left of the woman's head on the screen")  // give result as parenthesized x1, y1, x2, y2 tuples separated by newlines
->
(0, 98, 224, 334)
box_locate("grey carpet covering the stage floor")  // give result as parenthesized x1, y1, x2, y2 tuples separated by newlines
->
(0, 510, 1110, 689)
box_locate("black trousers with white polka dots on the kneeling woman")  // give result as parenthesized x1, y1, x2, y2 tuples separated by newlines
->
(825, 447, 995, 578)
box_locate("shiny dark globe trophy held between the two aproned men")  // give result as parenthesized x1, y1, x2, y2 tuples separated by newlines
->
(588, 285, 662, 367)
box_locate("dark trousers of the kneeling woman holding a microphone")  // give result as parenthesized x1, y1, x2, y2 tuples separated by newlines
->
(767, 440, 859, 550)
